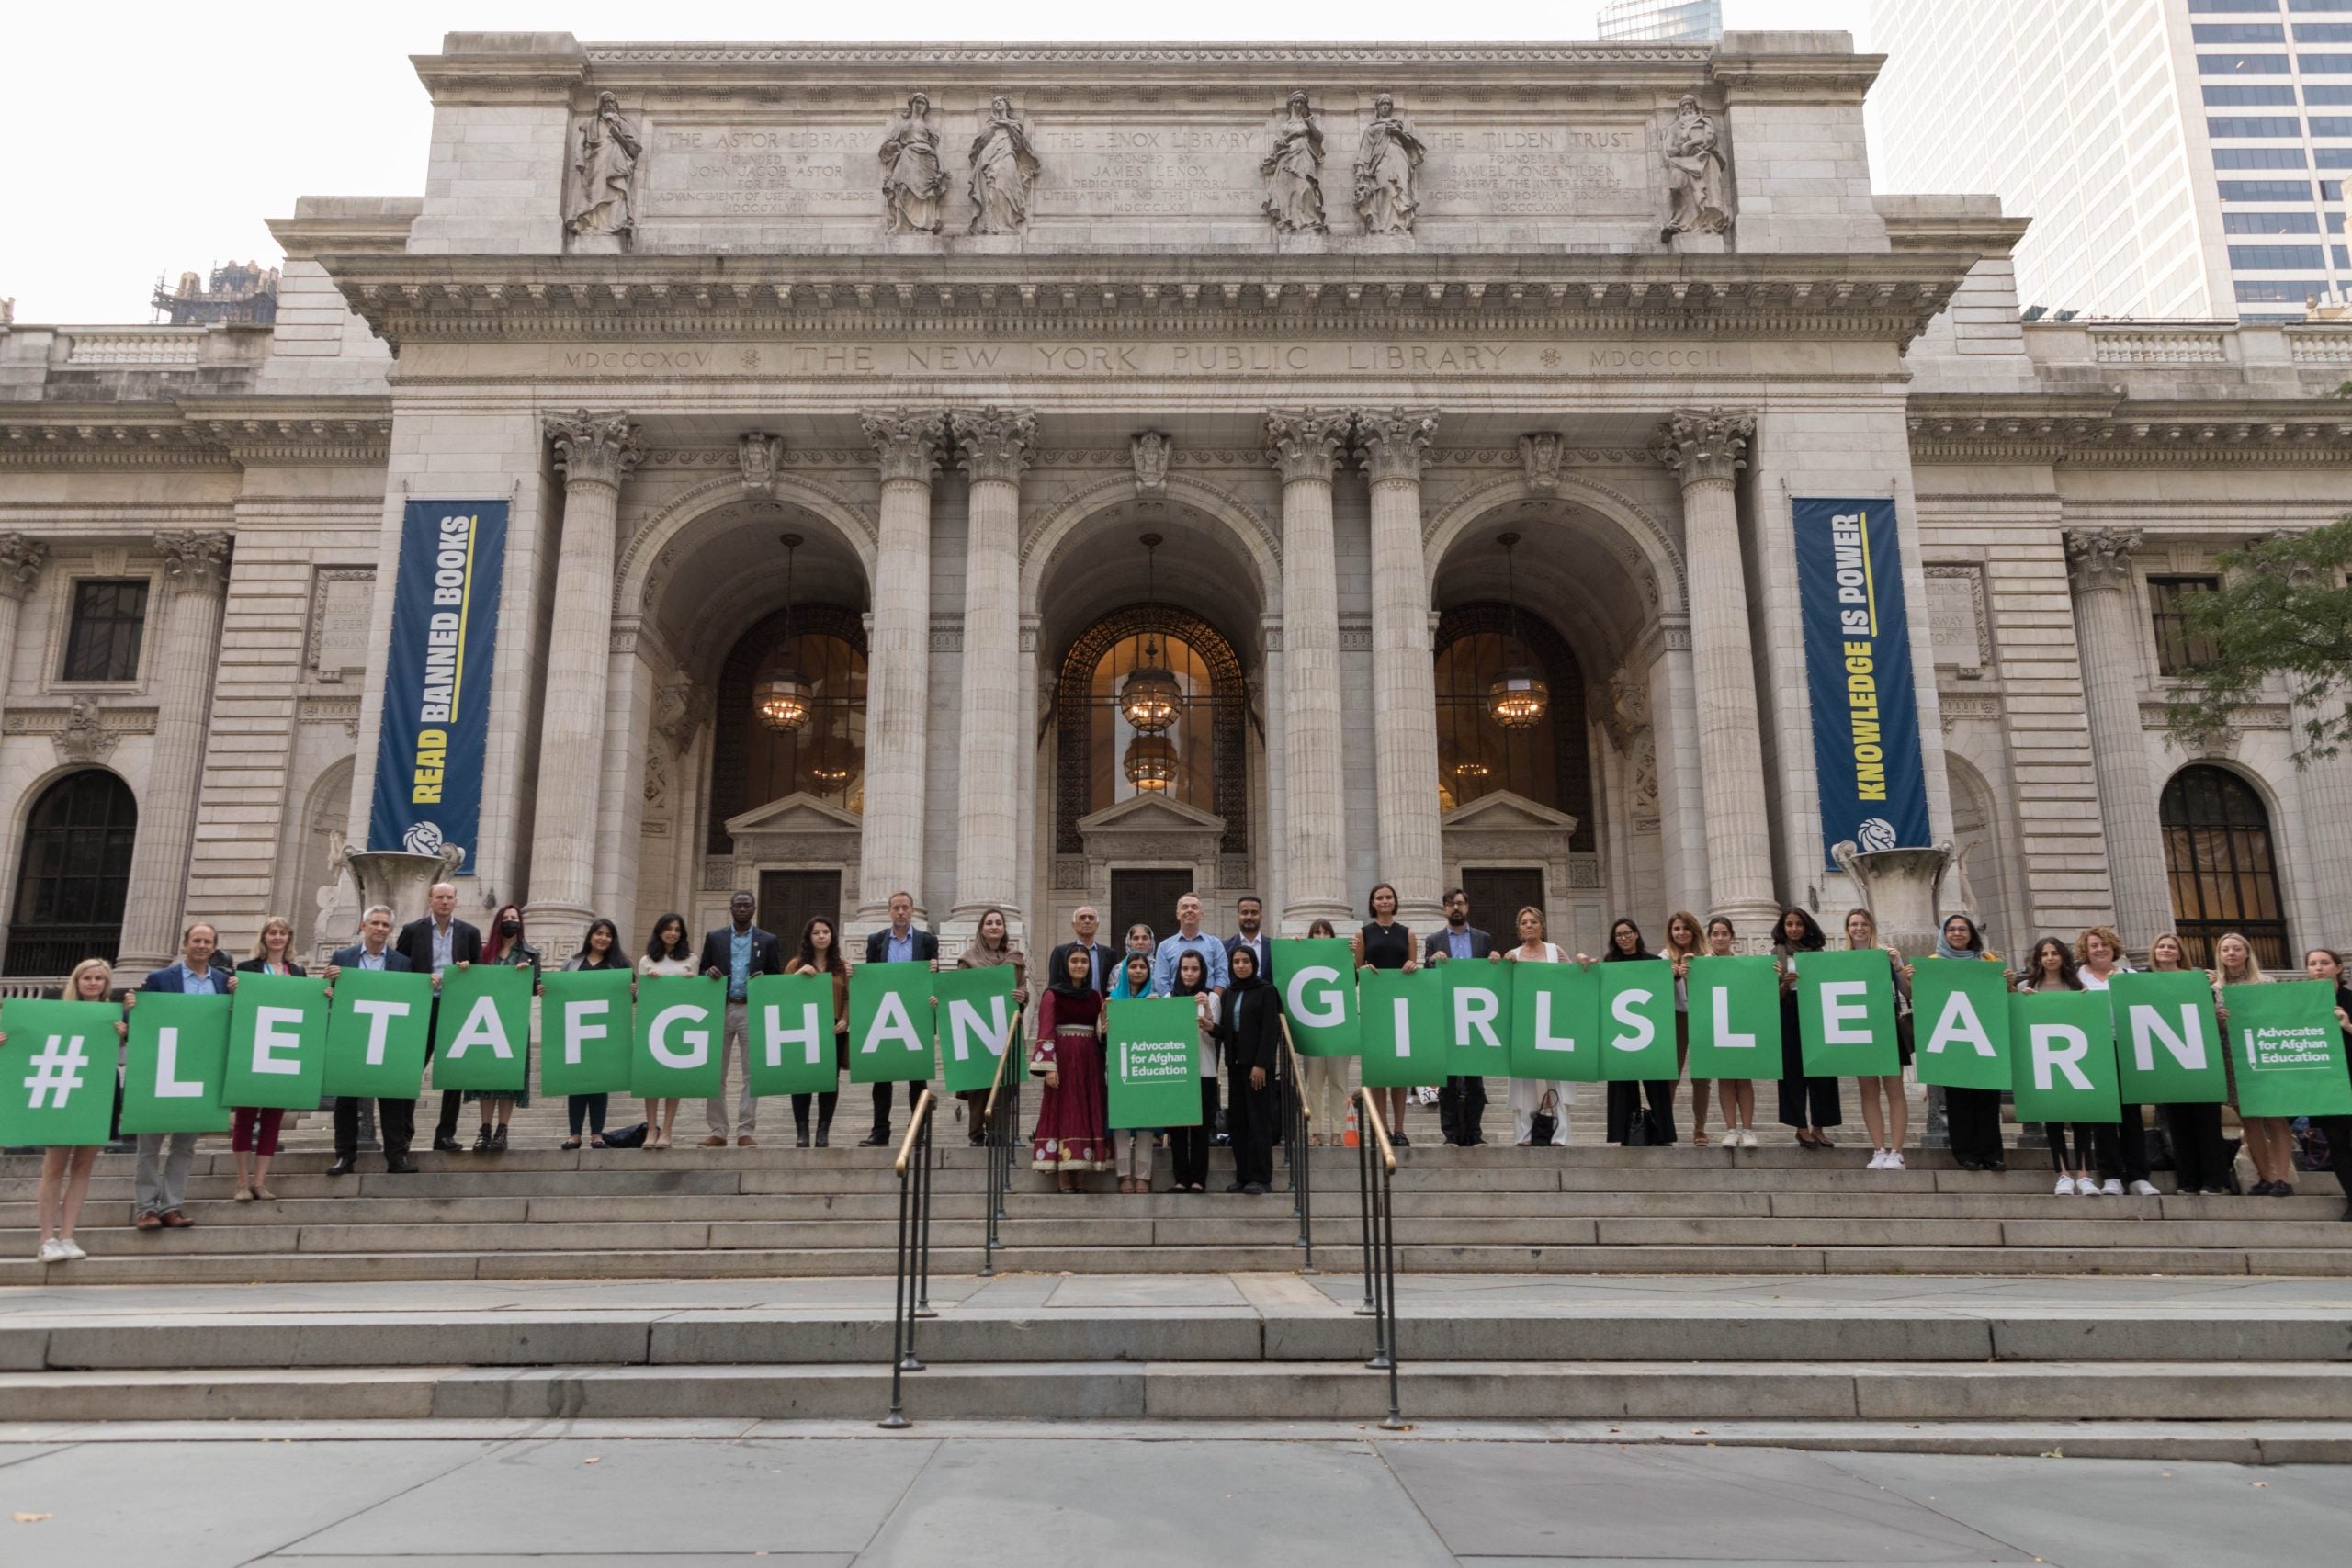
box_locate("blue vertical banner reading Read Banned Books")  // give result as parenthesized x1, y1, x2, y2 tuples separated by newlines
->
(367, 501, 505, 877)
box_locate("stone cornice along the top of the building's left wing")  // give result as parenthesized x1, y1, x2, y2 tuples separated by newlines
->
(0, 398, 393, 468)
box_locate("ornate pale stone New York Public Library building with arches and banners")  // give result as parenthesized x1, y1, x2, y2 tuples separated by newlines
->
(0, 33, 2352, 995)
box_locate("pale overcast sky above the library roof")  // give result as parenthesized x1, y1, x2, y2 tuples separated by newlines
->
(0, 0, 1871, 322)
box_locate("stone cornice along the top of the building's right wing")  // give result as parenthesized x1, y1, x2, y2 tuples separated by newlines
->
(1910, 395, 2352, 468)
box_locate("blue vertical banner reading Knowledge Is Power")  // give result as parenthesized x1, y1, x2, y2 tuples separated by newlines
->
(1792, 501, 1928, 870)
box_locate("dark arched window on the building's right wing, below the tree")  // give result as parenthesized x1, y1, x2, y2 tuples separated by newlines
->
(2154, 761, 2293, 968)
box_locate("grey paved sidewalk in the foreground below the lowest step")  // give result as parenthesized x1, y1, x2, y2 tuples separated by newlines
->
(0, 1432, 2352, 1568)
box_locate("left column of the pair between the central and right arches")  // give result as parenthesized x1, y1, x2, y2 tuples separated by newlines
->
(1265, 409, 1350, 933)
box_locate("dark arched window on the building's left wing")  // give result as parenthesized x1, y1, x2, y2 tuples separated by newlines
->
(0, 769, 139, 976)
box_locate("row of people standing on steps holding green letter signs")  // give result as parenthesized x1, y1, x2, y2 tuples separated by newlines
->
(0, 882, 2352, 1262)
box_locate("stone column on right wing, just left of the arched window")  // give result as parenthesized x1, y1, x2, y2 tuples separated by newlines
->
(2065, 529, 2173, 952)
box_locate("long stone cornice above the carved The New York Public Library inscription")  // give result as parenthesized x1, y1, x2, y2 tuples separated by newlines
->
(320, 247, 1975, 348)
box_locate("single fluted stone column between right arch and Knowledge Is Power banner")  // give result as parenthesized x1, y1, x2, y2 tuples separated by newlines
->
(1651, 409, 1778, 942)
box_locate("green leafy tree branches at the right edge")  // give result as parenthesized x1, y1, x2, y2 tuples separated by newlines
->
(2164, 517, 2352, 764)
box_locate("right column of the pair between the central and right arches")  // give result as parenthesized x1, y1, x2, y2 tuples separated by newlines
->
(1355, 409, 1444, 931)
